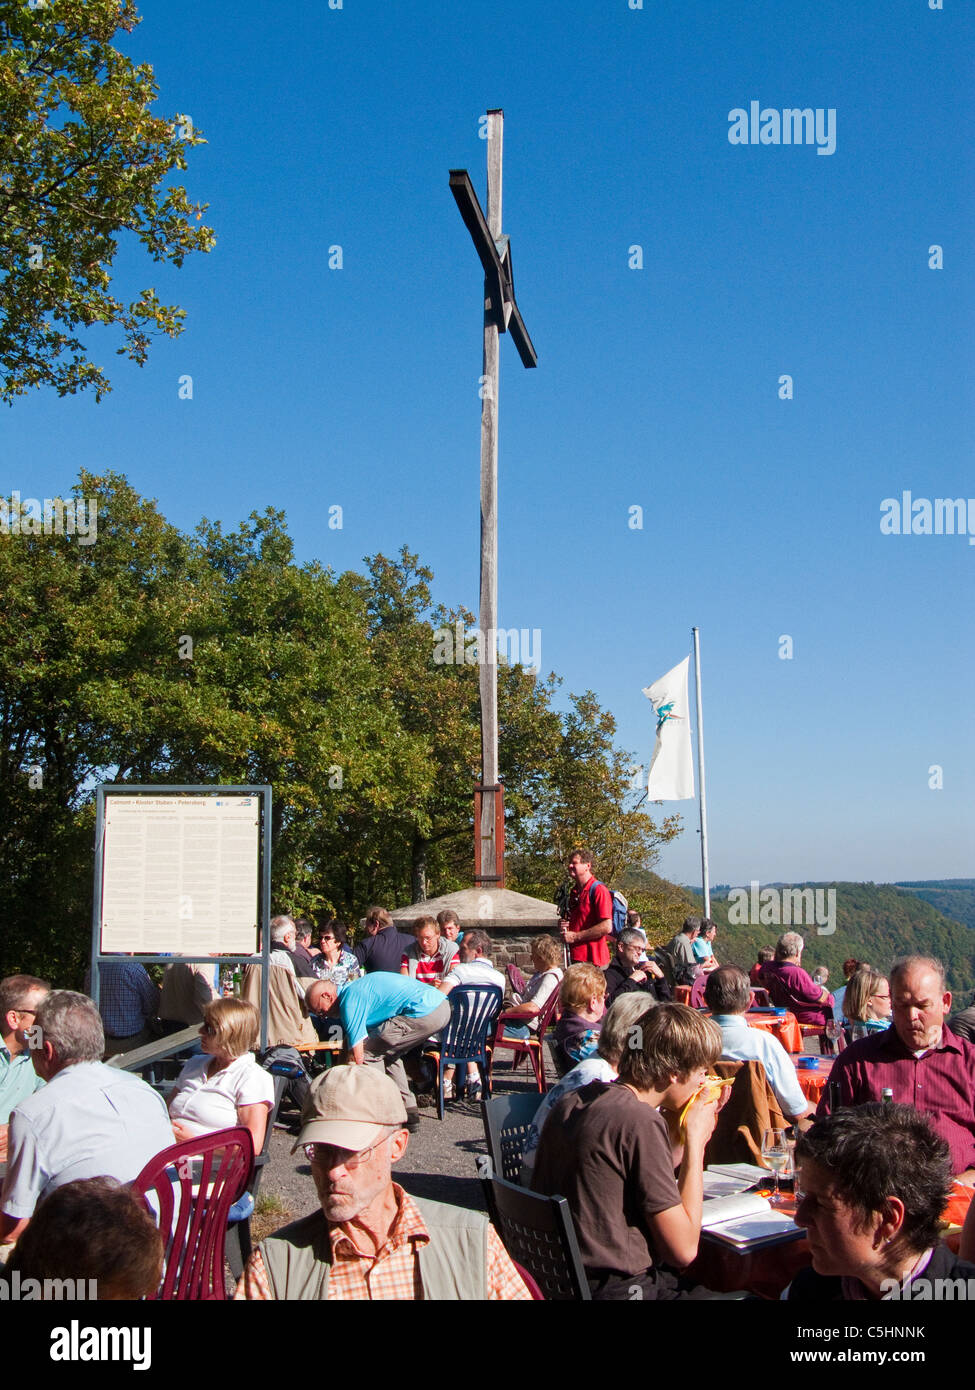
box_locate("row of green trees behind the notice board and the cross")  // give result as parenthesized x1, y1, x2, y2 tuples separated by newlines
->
(0, 474, 676, 983)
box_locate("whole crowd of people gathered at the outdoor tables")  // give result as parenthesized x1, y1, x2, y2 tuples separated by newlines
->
(0, 851, 975, 1301)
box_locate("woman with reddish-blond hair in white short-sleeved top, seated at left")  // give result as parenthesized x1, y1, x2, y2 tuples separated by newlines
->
(170, 998, 274, 1154)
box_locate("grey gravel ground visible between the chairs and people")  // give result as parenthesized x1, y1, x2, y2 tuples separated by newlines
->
(253, 1058, 539, 1240)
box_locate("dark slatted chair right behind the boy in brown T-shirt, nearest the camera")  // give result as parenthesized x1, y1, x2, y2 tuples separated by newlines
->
(490, 1177, 593, 1302)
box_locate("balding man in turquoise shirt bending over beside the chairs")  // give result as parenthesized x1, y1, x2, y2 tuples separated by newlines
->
(305, 970, 451, 1131)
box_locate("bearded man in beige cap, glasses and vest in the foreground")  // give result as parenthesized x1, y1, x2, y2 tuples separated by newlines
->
(236, 1066, 531, 1300)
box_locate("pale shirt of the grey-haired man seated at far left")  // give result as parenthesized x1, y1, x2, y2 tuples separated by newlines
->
(0, 1062, 175, 1220)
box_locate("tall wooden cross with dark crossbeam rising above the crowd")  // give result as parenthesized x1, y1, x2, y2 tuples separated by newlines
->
(451, 110, 538, 888)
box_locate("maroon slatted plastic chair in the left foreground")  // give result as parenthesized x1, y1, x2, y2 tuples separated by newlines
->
(132, 1127, 255, 1301)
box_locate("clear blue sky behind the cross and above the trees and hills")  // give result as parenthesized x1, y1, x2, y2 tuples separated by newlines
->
(0, 0, 975, 883)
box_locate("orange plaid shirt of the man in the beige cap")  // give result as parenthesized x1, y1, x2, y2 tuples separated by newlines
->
(234, 1183, 531, 1301)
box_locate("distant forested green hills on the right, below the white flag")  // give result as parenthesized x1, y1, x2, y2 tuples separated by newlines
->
(675, 880, 975, 1004)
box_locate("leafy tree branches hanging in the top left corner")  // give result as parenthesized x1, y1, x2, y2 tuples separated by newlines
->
(0, 0, 214, 403)
